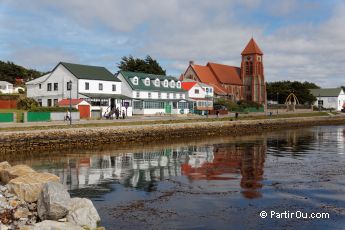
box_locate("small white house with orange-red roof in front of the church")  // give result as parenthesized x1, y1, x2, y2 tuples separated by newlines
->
(182, 79, 214, 114)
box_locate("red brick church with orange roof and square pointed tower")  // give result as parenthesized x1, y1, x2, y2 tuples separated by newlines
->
(180, 38, 266, 104)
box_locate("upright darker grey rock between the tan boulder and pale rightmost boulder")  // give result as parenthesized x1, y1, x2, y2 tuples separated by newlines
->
(37, 182, 71, 220)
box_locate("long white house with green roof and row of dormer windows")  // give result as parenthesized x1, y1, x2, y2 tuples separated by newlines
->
(117, 71, 190, 115)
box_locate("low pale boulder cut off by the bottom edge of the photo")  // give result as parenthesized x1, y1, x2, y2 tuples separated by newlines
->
(21, 220, 84, 230)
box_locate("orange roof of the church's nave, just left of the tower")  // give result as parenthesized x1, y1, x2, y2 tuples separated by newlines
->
(207, 62, 243, 85)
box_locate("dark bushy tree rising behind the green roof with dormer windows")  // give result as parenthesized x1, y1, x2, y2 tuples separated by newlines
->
(117, 55, 166, 75)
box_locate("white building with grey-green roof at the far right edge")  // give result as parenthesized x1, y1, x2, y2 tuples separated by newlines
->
(310, 88, 345, 111)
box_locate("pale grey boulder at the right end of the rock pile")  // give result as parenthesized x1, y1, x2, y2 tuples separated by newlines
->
(67, 198, 101, 229)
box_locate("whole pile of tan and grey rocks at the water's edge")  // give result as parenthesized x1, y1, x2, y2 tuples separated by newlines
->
(0, 161, 104, 230)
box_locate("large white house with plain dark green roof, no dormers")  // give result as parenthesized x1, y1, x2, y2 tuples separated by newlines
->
(26, 62, 132, 118)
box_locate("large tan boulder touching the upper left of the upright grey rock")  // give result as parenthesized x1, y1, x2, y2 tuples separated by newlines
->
(7, 172, 60, 202)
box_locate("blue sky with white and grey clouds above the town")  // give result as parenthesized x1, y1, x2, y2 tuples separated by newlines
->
(0, 0, 345, 87)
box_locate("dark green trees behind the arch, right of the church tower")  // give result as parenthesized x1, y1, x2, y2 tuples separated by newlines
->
(266, 81, 320, 104)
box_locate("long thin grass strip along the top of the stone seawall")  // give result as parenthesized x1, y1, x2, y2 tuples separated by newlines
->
(0, 112, 329, 131)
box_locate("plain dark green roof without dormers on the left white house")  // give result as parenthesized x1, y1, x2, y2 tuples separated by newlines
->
(60, 62, 120, 82)
